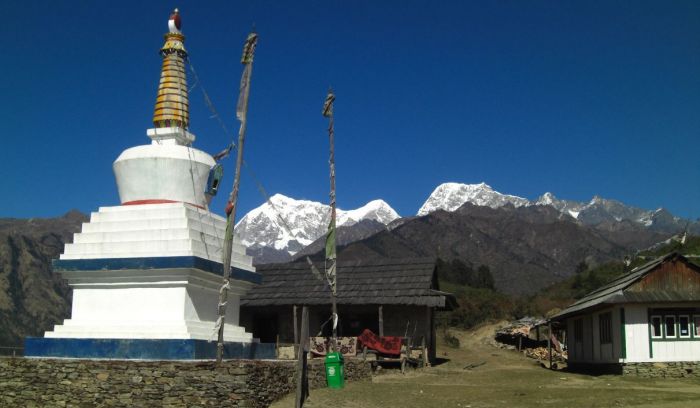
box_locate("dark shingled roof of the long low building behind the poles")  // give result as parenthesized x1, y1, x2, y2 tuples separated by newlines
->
(241, 258, 457, 310)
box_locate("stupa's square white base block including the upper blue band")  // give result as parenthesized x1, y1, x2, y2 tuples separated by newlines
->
(44, 256, 260, 343)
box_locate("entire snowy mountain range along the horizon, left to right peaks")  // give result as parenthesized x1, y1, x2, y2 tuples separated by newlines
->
(236, 183, 700, 263)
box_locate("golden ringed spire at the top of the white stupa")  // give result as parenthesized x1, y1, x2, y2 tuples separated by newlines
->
(153, 9, 190, 129)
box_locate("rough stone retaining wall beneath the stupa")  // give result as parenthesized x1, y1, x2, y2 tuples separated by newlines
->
(0, 358, 371, 407)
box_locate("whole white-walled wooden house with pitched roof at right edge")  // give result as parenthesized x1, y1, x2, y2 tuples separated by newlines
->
(552, 253, 700, 372)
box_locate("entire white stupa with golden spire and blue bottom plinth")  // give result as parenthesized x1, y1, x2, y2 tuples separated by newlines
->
(27, 10, 260, 358)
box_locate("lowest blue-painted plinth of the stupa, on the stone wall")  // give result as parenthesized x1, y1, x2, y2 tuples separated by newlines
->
(24, 337, 277, 360)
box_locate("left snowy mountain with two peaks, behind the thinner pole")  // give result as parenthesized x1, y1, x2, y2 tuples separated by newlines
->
(236, 194, 400, 255)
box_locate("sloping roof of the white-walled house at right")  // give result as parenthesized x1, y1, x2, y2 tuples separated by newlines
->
(552, 253, 700, 320)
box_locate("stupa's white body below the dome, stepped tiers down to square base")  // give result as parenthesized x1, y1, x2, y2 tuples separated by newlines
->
(44, 203, 261, 344)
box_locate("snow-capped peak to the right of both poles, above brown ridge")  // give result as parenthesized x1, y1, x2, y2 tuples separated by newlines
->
(418, 182, 530, 216)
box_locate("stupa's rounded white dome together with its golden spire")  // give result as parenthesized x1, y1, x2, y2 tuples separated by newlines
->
(113, 9, 216, 208)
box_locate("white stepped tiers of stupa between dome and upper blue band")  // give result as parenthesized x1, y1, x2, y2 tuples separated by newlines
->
(60, 203, 253, 270)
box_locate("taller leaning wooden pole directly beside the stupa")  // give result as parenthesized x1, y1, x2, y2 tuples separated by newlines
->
(216, 33, 258, 363)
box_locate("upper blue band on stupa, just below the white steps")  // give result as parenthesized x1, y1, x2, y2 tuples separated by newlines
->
(52, 256, 262, 284)
